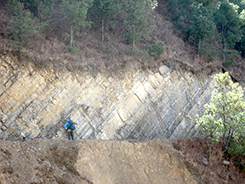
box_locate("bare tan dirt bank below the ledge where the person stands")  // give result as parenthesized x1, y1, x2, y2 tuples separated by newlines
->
(0, 139, 197, 184)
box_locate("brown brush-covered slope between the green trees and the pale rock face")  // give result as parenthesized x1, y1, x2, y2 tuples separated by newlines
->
(0, 0, 245, 83)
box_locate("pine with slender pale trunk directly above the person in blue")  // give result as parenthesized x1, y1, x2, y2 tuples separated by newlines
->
(62, 0, 93, 47)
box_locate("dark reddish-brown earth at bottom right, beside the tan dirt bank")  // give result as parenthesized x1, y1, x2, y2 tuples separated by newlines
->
(173, 138, 245, 184)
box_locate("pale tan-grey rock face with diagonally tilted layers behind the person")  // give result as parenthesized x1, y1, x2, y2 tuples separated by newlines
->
(0, 56, 213, 141)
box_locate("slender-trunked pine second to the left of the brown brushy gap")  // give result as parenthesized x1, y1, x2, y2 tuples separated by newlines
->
(90, 0, 122, 46)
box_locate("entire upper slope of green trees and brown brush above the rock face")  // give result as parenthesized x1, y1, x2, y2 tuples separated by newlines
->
(0, 0, 245, 81)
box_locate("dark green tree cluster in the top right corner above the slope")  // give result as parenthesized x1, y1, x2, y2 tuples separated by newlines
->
(169, 0, 245, 65)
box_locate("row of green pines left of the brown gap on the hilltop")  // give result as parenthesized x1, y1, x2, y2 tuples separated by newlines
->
(1, 0, 157, 53)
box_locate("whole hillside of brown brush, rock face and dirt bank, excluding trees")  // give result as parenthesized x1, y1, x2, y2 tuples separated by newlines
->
(0, 0, 245, 184)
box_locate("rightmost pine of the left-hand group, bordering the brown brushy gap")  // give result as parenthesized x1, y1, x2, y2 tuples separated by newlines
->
(124, 0, 154, 50)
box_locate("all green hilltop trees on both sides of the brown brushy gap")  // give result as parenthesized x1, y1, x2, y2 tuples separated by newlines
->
(1, 0, 245, 60)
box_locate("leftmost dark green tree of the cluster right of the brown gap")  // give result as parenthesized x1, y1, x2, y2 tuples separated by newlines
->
(169, 0, 217, 50)
